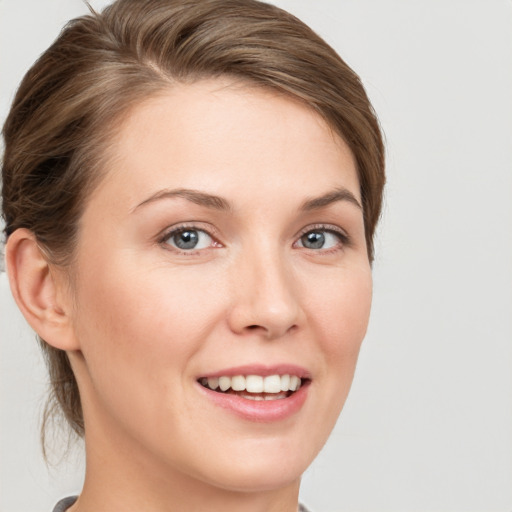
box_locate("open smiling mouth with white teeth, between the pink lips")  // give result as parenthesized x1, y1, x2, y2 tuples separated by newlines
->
(198, 374, 309, 400)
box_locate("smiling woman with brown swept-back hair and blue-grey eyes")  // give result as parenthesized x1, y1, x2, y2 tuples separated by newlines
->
(2, 0, 384, 512)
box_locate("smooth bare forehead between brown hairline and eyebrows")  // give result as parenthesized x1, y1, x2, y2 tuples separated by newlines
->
(89, 79, 360, 212)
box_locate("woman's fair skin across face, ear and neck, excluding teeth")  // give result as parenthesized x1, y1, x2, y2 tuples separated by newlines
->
(7, 79, 372, 512)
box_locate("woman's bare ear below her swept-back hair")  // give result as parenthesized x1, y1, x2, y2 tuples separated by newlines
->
(5, 228, 79, 351)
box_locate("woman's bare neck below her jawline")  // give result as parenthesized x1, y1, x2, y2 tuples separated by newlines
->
(69, 420, 300, 512)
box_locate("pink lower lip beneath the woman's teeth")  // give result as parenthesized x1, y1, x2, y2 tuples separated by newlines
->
(197, 382, 310, 423)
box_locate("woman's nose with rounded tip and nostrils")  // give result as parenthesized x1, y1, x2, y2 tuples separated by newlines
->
(228, 250, 303, 340)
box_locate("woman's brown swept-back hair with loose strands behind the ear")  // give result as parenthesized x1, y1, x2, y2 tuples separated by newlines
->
(2, 0, 385, 449)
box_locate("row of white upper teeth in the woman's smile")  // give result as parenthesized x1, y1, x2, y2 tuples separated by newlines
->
(201, 375, 301, 393)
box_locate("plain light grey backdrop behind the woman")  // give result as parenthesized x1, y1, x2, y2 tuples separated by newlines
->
(0, 0, 512, 512)
